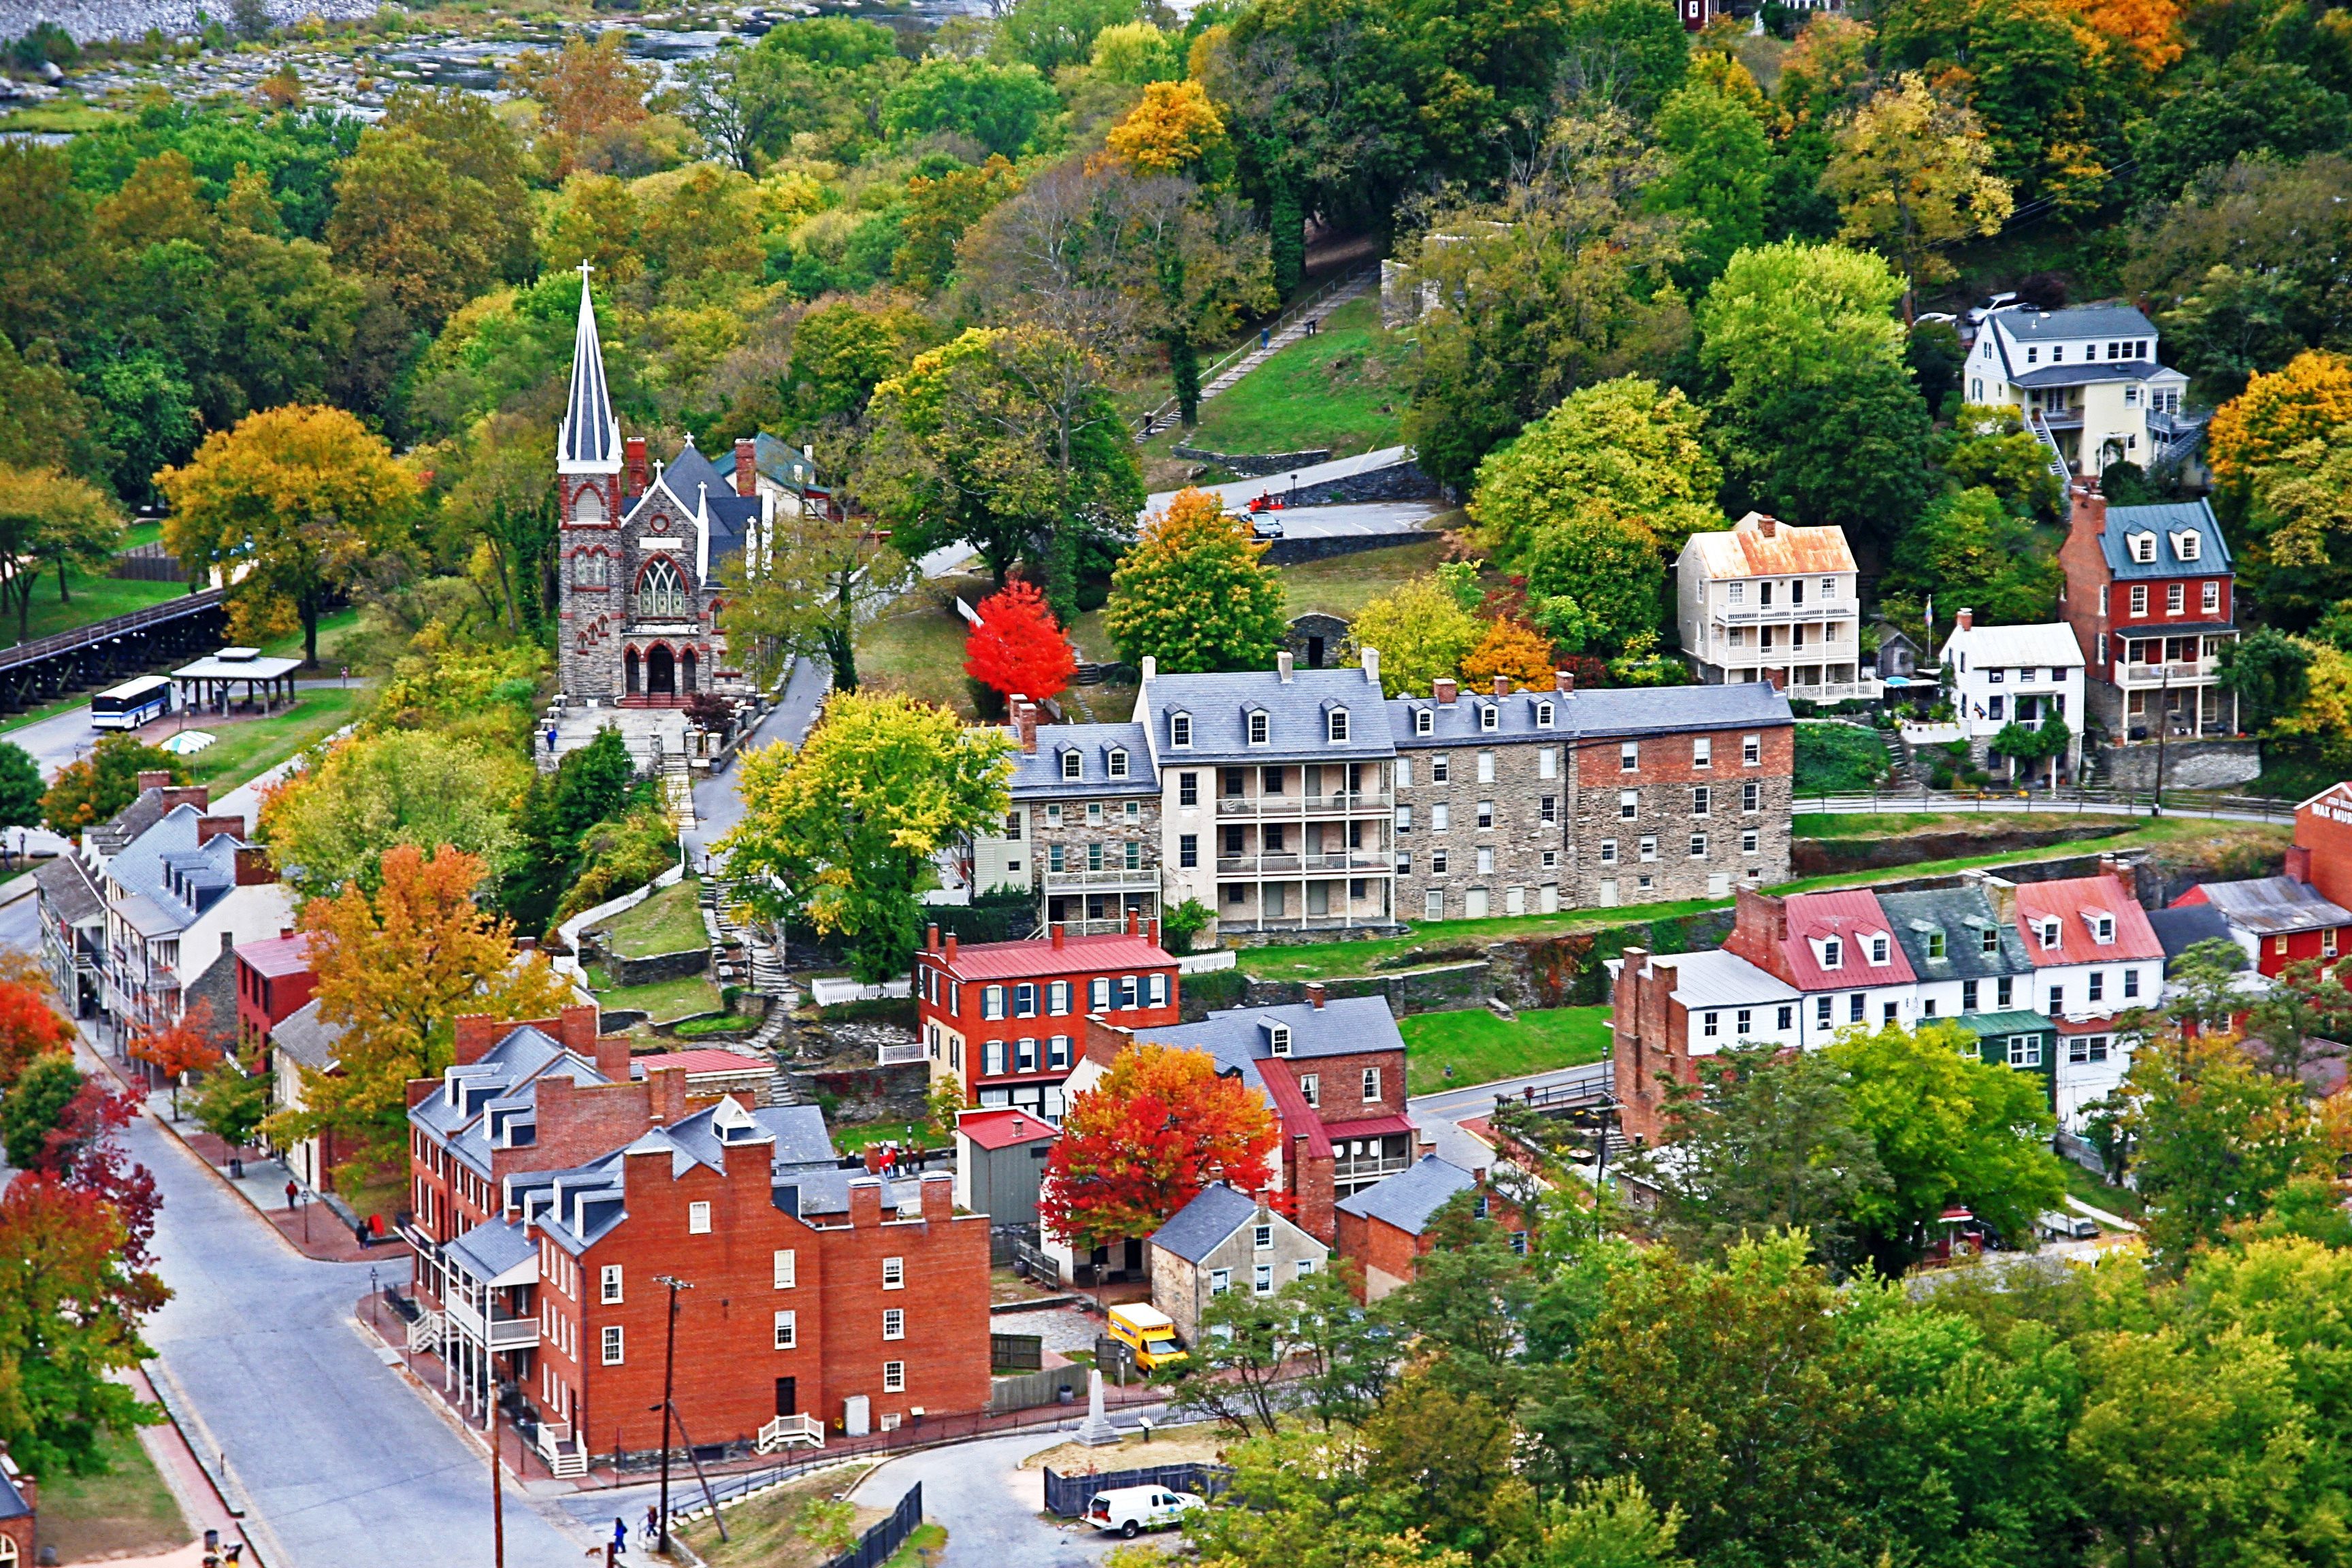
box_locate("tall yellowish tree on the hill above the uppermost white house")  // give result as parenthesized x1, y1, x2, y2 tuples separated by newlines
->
(1820, 71, 2011, 320)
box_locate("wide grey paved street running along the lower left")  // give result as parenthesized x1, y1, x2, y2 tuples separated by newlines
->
(129, 1119, 588, 1568)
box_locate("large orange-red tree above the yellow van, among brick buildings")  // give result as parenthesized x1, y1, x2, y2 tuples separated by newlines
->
(1037, 1044, 1275, 1251)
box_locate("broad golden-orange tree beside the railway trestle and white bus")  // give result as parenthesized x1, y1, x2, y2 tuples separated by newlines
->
(158, 404, 416, 666)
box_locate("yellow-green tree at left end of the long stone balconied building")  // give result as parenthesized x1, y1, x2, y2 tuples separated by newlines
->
(713, 691, 1011, 985)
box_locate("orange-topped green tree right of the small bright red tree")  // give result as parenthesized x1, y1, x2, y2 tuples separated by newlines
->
(1103, 489, 1286, 674)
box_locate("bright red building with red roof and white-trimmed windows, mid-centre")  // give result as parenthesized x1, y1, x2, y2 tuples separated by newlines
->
(915, 912, 1176, 1124)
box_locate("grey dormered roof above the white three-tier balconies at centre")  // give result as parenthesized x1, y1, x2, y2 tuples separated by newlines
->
(1136, 668, 1397, 769)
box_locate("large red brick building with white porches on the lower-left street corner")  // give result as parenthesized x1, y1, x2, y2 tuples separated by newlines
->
(404, 1009, 988, 1474)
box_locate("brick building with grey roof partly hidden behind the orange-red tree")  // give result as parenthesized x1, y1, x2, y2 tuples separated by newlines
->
(1070, 985, 1418, 1267)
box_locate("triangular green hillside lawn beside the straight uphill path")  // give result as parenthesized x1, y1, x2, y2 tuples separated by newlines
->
(1150, 296, 1414, 456)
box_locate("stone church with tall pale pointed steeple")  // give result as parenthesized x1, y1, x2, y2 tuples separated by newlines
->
(555, 268, 774, 708)
